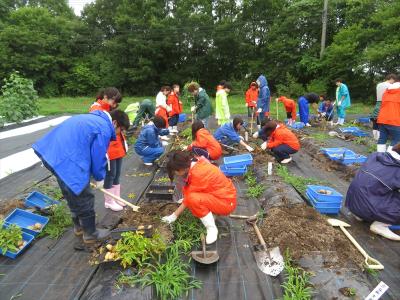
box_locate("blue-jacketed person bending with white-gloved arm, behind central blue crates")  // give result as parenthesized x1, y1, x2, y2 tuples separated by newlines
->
(214, 117, 254, 152)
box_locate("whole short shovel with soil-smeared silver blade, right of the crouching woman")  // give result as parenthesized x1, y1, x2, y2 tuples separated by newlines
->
(247, 218, 285, 277)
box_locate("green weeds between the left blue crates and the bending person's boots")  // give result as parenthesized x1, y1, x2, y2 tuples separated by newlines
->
(39, 201, 72, 239)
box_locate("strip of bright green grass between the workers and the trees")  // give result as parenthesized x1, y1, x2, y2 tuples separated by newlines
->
(39, 95, 373, 120)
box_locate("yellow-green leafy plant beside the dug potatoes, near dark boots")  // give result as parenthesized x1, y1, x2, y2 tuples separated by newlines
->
(115, 232, 166, 268)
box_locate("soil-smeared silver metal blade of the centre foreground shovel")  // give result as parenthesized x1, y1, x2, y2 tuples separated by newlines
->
(254, 247, 285, 277)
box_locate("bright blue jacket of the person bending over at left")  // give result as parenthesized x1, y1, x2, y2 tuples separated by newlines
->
(32, 110, 116, 195)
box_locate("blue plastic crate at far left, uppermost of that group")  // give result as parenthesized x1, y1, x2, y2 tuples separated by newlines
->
(4, 208, 49, 237)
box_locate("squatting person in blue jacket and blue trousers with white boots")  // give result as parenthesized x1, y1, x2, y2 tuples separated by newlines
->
(135, 116, 169, 166)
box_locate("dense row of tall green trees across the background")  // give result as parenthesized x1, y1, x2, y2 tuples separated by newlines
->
(0, 0, 400, 101)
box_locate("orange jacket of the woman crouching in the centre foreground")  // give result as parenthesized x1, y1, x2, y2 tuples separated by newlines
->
(183, 157, 236, 202)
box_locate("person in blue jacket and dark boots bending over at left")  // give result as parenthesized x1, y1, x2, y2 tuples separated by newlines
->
(32, 110, 129, 243)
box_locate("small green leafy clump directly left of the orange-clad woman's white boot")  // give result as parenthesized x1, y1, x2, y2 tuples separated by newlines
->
(172, 210, 205, 246)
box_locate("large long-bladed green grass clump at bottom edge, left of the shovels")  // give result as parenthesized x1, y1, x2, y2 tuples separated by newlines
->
(118, 240, 201, 300)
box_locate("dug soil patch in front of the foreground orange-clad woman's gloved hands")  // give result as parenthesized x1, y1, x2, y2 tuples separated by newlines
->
(118, 202, 178, 242)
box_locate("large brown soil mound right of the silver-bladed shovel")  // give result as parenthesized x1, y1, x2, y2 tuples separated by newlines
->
(252, 204, 363, 266)
